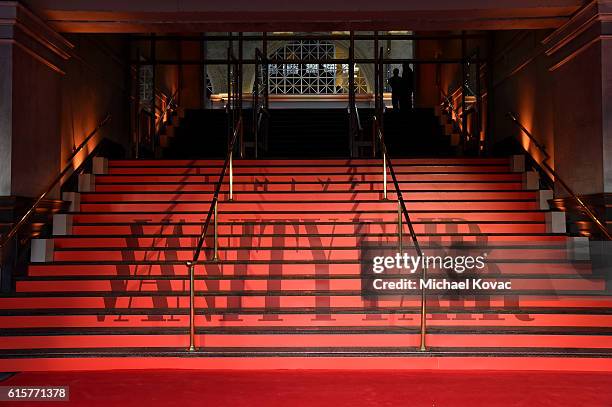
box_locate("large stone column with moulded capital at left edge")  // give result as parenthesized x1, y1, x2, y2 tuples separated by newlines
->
(0, 1, 71, 197)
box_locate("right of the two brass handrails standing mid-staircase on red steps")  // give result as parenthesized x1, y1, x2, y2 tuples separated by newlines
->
(373, 115, 427, 351)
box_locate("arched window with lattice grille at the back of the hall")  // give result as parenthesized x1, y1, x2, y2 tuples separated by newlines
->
(268, 40, 367, 95)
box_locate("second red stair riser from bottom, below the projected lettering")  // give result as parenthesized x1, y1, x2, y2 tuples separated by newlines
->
(0, 328, 612, 349)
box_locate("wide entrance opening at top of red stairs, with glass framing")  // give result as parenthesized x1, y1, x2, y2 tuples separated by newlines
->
(132, 31, 487, 158)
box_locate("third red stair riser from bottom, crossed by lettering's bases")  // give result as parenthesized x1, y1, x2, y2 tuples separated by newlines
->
(0, 309, 612, 329)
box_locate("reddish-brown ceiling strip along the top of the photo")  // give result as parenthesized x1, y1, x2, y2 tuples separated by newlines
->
(23, 0, 587, 33)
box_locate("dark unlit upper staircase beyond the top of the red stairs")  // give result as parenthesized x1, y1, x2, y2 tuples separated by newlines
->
(164, 109, 453, 159)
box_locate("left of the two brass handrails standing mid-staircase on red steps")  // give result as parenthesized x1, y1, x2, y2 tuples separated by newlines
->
(187, 117, 242, 352)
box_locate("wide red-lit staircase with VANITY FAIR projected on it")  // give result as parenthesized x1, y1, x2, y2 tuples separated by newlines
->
(0, 159, 612, 371)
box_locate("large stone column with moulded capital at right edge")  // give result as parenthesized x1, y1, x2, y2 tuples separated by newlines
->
(543, 0, 612, 197)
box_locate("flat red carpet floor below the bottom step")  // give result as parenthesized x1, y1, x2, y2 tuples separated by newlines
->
(0, 370, 612, 407)
